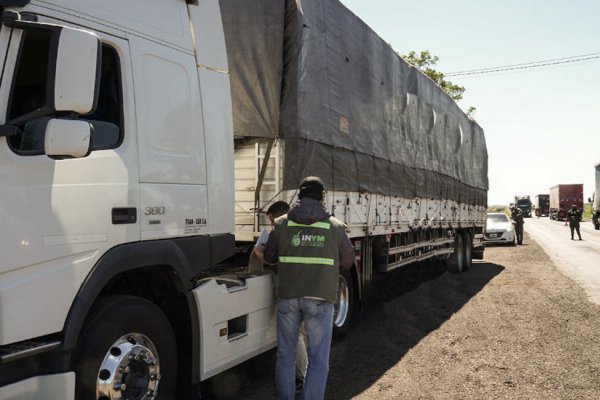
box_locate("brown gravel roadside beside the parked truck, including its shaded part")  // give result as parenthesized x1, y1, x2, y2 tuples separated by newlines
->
(207, 234, 600, 400)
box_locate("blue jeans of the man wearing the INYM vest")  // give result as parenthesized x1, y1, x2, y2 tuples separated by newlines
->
(275, 297, 333, 400)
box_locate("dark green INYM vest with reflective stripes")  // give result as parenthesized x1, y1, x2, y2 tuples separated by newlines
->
(274, 218, 340, 303)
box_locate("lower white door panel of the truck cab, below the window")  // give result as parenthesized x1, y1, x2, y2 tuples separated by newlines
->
(0, 153, 139, 345)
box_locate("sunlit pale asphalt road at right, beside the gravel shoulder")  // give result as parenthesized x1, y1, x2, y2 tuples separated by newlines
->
(524, 218, 600, 304)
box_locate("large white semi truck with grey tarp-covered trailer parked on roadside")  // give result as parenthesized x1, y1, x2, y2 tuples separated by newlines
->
(0, 0, 487, 400)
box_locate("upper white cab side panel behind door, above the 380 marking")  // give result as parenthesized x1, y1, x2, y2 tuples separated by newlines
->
(130, 36, 206, 185)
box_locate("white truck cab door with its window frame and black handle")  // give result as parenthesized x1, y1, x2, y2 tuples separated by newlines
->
(0, 20, 140, 344)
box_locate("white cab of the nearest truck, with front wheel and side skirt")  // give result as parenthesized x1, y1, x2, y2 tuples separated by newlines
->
(0, 0, 275, 399)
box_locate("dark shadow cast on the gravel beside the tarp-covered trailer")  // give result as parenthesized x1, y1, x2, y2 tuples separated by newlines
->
(326, 262, 504, 399)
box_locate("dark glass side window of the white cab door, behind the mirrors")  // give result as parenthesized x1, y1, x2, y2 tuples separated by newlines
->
(7, 33, 122, 155)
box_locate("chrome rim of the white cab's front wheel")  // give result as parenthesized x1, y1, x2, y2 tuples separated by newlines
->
(96, 333, 161, 400)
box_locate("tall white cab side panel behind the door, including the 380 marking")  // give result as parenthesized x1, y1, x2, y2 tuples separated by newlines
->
(130, 36, 209, 239)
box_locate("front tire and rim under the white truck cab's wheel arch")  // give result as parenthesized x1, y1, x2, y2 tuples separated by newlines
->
(74, 295, 177, 400)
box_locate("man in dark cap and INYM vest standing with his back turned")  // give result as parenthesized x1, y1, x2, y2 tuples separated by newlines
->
(263, 176, 355, 400)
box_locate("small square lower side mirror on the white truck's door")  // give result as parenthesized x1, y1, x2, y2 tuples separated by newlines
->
(44, 119, 93, 158)
